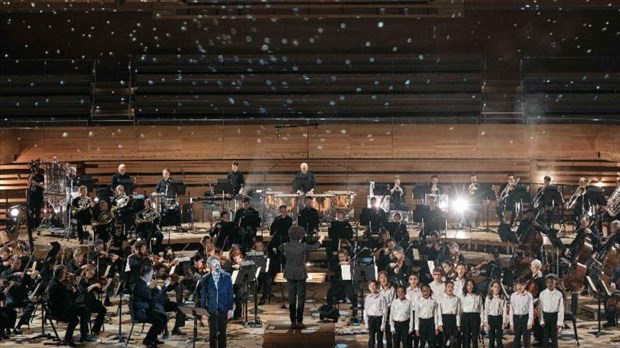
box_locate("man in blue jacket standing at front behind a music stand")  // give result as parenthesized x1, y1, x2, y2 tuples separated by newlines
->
(199, 257, 234, 348)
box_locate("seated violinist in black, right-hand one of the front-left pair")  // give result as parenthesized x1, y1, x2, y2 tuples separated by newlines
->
(76, 265, 108, 336)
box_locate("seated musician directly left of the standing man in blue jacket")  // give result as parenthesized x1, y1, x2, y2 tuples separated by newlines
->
(153, 263, 185, 339)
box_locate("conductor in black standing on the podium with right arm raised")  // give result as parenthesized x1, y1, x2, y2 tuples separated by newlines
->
(280, 226, 324, 330)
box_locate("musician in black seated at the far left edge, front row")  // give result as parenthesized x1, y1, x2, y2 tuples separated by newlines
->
(0, 255, 38, 334)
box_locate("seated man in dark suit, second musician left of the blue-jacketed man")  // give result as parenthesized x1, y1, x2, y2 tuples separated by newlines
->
(130, 265, 167, 348)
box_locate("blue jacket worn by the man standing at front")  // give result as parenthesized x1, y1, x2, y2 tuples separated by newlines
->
(199, 271, 234, 315)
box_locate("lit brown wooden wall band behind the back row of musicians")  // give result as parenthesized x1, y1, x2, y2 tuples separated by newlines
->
(0, 124, 620, 223)
